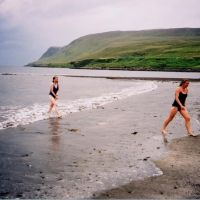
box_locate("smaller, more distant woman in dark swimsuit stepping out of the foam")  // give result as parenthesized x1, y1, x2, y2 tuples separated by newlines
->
(48, 76, 61, 118)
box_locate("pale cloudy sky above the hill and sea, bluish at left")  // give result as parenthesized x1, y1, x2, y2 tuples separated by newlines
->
(0, 0, 200, 65)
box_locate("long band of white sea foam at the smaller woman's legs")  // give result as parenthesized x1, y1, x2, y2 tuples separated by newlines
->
(0, 81, 157, 129)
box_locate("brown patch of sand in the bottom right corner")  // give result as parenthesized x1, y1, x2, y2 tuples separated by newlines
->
(95, 136, 200, 199)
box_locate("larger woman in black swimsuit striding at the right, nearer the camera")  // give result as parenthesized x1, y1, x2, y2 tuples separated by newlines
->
(161, 80, 194, 142)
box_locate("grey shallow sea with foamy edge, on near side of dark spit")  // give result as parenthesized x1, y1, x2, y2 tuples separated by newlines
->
(0, 68, 157, 129)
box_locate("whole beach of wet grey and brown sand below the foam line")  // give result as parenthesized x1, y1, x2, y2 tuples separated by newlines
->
(0, 82, 200, 198)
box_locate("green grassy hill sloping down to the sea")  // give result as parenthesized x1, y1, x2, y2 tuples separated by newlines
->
(29, 28, 200, 71)
